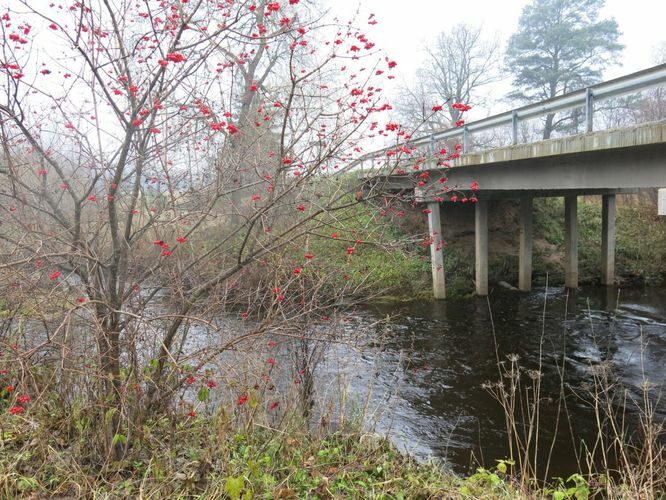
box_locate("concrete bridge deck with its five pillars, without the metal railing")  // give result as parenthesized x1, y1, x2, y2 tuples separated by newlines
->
(366, 124, 666, 298)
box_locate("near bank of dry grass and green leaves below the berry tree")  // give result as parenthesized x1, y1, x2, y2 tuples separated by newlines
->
(0, 402, 513, 499)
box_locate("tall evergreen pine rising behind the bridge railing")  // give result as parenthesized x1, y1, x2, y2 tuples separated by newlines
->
(506, 0, 623, 139)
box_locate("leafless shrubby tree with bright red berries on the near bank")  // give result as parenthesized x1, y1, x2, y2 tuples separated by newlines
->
(0, 0, 410, 458)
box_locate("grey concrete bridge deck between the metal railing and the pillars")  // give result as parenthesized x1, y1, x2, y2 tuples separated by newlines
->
(366, 122, 666, 201)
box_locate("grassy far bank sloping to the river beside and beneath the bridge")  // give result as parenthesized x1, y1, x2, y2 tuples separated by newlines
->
(128, 191, 666, 307)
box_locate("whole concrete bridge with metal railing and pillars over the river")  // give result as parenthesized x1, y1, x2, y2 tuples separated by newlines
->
(357, 64, 666, 299)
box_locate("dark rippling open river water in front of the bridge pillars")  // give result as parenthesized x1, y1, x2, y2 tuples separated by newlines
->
(319, 288, 666, 476)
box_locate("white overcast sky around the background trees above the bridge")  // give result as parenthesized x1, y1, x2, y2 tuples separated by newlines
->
(324, 0, 666, 114)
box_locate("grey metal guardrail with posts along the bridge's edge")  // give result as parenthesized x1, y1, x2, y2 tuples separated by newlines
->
(354, 64, 666, 165)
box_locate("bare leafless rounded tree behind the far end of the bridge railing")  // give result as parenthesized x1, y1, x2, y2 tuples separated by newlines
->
(397, 24, 498, 131)
